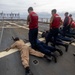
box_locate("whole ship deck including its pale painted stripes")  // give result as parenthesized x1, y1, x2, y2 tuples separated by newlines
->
(0, 21, 75, 75)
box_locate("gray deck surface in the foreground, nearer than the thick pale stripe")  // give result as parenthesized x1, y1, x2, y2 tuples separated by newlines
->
(0, 46, 75, 75)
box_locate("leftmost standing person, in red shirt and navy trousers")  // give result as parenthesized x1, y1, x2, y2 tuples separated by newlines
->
(27, 7, 38, 49)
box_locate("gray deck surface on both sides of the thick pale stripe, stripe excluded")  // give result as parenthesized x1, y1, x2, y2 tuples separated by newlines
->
(0, 21, 75, 75)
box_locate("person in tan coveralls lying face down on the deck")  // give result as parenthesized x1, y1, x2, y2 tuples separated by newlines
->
(6, 37, 51, 75)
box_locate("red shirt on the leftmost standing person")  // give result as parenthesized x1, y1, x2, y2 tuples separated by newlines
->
(29, 12, 38, 29)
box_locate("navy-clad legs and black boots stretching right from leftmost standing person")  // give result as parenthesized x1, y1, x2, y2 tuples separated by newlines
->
(37, 40, 58, 63)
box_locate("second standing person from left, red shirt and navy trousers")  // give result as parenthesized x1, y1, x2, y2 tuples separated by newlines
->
(46, 9, 62, 45)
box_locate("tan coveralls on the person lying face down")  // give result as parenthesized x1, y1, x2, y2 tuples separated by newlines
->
(11, 40, 44, 68)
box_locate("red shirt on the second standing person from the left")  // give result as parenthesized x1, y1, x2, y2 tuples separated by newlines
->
(51, 14, 61, 28)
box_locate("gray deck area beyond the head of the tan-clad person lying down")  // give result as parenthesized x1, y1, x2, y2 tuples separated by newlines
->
(0, 28, 28, 50)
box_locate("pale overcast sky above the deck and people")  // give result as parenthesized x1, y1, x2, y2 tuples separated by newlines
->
(0, 0, 75, 13)
